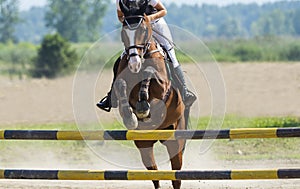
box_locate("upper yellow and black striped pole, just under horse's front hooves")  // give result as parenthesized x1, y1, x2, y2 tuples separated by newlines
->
(0, 128, 300, 140)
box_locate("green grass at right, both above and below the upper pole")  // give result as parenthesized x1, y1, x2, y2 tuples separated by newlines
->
(213, 116, 300, 160)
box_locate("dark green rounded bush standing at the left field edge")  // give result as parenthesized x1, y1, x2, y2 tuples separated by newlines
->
(31, 34, 78, 78)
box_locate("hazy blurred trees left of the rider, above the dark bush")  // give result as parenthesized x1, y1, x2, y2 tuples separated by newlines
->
(0, 0, 109, 43)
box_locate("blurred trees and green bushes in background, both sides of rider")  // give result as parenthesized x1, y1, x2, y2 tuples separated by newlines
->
(0, 0, 300, 78)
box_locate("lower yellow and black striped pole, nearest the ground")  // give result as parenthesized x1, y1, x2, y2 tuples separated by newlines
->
(0, 169, 300, 180)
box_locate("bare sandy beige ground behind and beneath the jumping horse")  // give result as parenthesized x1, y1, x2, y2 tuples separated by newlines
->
(0, 63, 300, 189)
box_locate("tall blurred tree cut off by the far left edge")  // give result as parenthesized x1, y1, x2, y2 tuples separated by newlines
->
(0, 0, 20, 43)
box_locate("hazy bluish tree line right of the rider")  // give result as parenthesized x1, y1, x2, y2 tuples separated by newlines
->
(167, 1, 300, 38)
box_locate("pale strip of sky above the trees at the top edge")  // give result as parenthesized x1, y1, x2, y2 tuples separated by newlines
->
(20, 0, 288, 10)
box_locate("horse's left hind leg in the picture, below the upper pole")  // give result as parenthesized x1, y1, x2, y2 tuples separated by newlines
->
(134, 141, 160, 189)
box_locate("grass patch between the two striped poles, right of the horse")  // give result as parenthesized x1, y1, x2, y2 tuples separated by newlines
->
(213, 138, 300, 160)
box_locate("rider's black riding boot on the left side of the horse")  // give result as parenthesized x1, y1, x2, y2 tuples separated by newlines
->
(96, 57, 121, 112)
